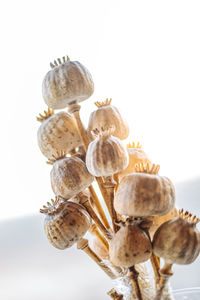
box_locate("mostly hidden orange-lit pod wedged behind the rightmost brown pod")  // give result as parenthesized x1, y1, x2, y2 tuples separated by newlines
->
(148, 207, 178, 238)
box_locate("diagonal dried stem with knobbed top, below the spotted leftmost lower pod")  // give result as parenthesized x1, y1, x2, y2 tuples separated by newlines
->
(77, 239, 116, 279)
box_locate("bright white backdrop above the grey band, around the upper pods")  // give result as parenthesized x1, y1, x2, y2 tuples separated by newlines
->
(0, 0, 200, 219)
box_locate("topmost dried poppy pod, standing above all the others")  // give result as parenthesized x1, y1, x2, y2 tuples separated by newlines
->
(42, 56, 94, 109)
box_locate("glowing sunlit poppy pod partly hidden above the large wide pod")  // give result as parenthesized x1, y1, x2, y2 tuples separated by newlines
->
(117, 142, 151, 181)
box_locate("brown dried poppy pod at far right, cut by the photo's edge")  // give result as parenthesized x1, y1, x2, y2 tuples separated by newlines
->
(153, 210, 200, 265)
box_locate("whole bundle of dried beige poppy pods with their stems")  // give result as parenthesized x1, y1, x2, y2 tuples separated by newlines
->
(37, 56, 200, 300)
